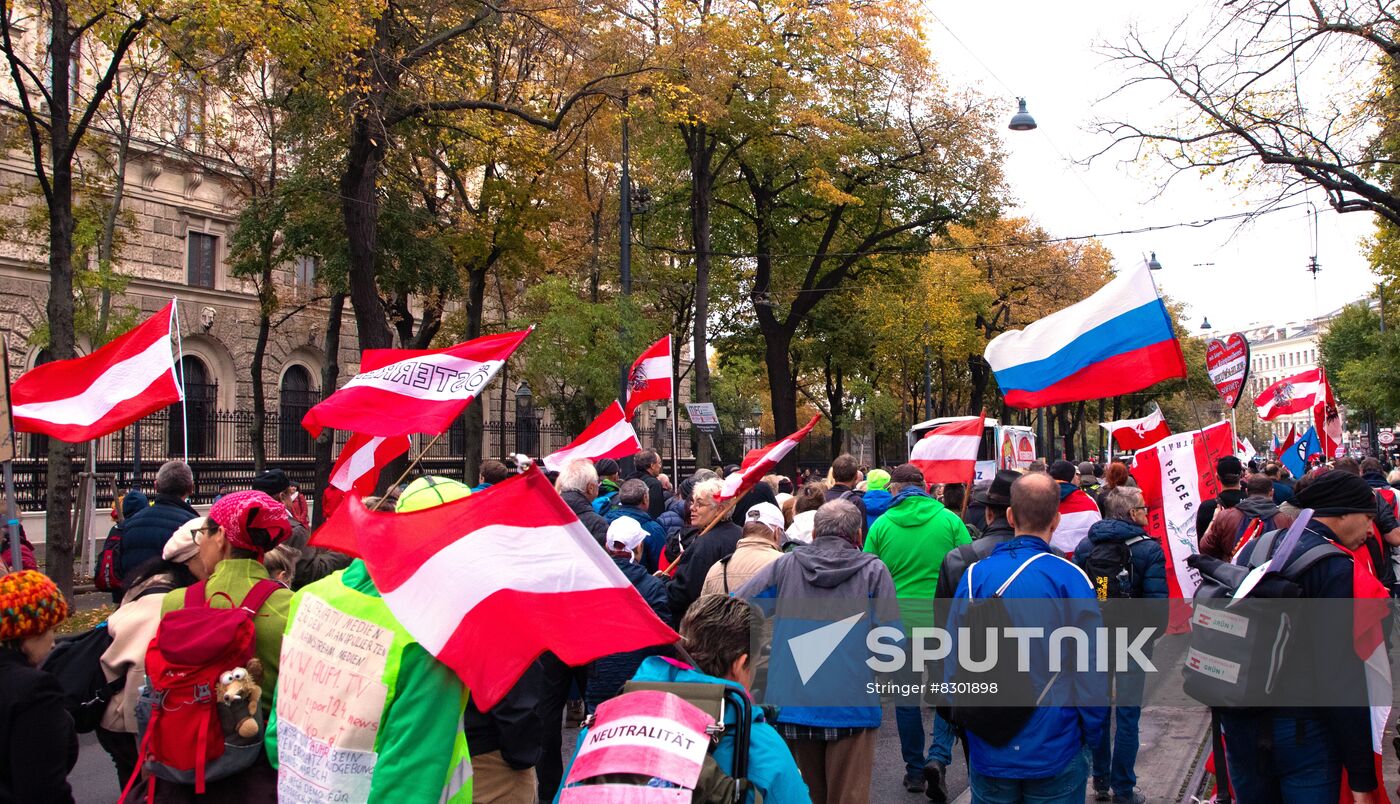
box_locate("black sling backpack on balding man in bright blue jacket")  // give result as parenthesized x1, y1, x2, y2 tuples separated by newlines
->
(939, 553, 1060, 747)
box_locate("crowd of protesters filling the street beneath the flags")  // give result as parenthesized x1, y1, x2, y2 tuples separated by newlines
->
(0, 450, 1400, 804)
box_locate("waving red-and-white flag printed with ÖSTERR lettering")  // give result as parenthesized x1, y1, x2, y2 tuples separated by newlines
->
(301, 328, 533, 436)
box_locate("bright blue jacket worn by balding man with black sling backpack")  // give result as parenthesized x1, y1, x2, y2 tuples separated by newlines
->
(944, 536, 1107, 779)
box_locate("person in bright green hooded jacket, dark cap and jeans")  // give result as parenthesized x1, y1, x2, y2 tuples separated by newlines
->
(865, 464, 972, 801)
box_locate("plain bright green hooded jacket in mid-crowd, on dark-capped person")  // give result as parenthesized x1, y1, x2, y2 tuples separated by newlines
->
(865, 487, 972, 625)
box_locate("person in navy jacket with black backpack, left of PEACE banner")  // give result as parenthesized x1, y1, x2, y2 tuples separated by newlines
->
(1074, 486, 1168, 804)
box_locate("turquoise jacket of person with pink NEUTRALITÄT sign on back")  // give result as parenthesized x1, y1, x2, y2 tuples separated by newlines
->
(554, 656, 812, 804)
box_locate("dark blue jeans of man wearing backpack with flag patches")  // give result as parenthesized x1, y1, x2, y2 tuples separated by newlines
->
(1221, 712, 1341, 804)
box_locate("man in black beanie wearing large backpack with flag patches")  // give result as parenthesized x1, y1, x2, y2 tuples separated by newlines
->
(1219, 471, 1378, 801)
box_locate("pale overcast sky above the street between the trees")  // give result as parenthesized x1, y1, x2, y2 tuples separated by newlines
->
(928, 0, 1375, 329)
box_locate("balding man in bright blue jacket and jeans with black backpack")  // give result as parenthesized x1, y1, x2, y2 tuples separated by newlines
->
(944, 473, 1107, 804)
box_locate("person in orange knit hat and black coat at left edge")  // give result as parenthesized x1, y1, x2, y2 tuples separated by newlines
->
(0, 570, 78, 804)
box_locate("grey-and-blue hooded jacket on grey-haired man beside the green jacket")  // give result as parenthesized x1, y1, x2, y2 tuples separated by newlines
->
(734, 536, 900, 728)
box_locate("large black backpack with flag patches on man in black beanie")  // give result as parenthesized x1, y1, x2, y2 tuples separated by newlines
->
(1182, 510, 1347, 707)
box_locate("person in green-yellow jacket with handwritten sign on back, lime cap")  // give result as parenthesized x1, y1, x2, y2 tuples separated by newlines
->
(266, 478, 472, 804)
